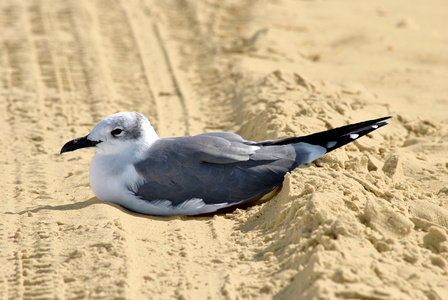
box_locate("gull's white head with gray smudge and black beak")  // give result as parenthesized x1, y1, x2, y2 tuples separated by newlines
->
(61, 112, 159, 155)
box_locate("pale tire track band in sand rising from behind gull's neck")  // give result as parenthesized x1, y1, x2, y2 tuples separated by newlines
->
(89, 0, 189, 137)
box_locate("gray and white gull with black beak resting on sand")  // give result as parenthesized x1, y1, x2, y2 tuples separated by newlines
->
(61, 112, 390, 215)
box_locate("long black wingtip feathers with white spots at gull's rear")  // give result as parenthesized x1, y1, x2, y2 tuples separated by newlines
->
(257, 117, 391, 153)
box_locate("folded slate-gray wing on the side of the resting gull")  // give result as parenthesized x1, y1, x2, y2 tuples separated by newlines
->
(130, 132, 300, 205)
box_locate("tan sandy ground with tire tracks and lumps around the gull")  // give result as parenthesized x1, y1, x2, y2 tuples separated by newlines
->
(0, 0, 448, 299)
